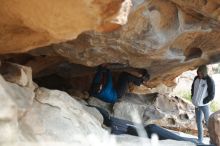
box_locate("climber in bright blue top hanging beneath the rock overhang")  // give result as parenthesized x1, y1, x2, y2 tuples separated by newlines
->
(89, 65, 150, 103)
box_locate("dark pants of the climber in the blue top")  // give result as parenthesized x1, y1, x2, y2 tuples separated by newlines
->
(116, 72, 143, 98)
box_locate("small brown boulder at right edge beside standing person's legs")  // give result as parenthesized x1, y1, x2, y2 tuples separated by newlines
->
(208, 111, 220, 146)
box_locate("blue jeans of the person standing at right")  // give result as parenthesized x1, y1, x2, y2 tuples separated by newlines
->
(195, 105, 210, 142)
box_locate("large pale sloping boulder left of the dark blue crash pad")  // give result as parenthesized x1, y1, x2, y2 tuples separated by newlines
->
(20, 88, 105, 142)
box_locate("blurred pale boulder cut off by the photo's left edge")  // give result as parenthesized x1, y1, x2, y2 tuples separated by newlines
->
(0, 75, 35, 143)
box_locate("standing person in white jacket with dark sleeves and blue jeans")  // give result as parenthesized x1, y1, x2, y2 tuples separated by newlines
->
(191, 65, 215, 143)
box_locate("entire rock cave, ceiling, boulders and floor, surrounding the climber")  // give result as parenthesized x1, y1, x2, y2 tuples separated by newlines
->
(0, 0, 220, 146)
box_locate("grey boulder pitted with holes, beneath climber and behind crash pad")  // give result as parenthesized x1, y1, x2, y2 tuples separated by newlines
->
(113, 93, 196, 130)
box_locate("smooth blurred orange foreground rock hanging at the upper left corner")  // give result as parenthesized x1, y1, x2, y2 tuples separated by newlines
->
(0, 0, 131, 54)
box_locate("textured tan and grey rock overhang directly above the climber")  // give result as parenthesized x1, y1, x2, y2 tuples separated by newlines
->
(4, 0, 217, 87)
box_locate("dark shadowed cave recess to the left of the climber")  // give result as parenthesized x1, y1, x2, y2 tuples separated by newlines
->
(33, 62, 96, 93)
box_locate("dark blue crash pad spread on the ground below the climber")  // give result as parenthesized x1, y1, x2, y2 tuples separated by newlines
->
(88, 105, 198, 144)
